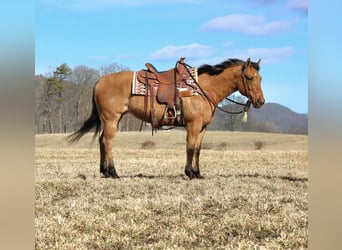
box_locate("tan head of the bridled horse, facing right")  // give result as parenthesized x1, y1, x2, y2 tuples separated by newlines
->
(238, 58, 265, 108)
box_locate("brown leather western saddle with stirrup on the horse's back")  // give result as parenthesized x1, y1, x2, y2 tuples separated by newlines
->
(136, 57, 192, 129)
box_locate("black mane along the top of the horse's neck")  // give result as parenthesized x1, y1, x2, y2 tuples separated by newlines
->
(197, 58, 260, 76)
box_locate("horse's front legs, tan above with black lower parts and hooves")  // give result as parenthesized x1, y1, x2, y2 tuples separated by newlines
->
(185, 127, 205, 180)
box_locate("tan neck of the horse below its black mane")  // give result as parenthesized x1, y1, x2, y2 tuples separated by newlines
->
(199, 67, 241, 104)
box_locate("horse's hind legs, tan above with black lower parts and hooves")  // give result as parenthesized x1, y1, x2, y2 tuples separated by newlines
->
(99, 119, 119, 178)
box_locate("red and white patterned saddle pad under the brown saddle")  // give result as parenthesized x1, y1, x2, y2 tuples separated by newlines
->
(132, 67, 198, 97)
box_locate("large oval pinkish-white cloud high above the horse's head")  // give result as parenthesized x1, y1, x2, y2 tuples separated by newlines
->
(201, 14, 291, 35)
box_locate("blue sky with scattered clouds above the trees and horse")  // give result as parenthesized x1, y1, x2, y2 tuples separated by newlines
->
(35, 0, 308, 113)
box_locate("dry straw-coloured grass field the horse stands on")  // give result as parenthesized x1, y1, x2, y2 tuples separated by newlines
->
(35, 130, 308, 249)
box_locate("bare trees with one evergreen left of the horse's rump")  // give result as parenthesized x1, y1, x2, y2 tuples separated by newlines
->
(35, 63, 133, 133)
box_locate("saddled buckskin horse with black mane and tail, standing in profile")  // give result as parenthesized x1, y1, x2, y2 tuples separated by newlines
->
(68, 58, 265, 180)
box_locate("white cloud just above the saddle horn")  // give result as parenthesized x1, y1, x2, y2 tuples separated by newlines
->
(149, 43, 213, 60)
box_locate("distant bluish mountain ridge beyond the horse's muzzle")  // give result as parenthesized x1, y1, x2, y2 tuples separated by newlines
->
(249, 103, 308, 134)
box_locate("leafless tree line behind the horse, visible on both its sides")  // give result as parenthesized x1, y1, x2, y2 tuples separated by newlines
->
(35, 63, 304, 133)
